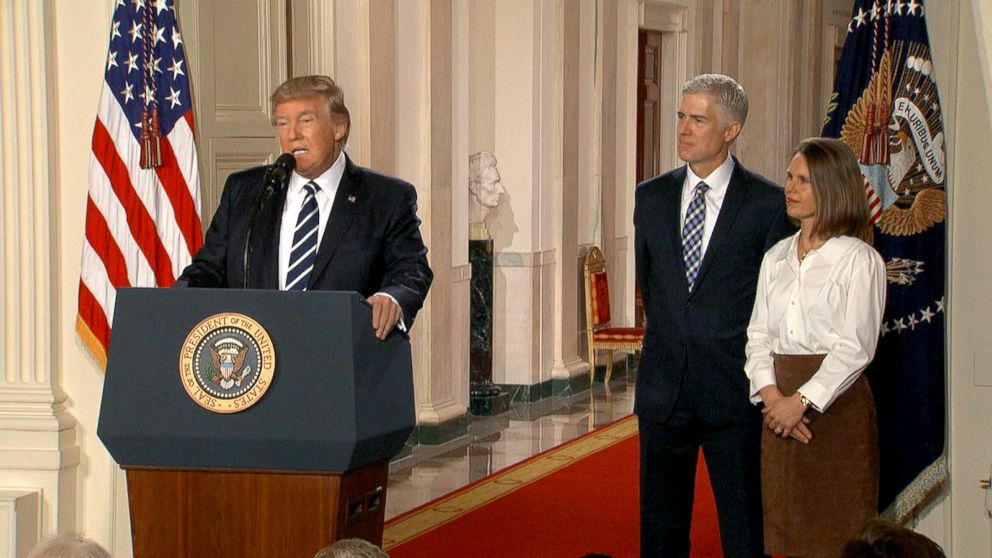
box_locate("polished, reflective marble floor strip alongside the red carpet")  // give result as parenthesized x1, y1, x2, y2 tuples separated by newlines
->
(386, 365, 634, 521)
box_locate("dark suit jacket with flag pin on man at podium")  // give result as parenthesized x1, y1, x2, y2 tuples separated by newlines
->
(177, 155, 434, 327)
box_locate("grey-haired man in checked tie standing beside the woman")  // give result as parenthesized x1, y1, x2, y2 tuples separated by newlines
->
(634, 74, 794, 557)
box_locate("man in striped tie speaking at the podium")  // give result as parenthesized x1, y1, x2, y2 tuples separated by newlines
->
(176, 76, 434, 339)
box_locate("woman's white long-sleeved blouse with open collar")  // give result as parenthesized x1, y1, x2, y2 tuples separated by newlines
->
(744, 233, 886, 412)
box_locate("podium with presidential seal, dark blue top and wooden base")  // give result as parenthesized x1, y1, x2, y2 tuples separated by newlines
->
(97, 289, 415, 558)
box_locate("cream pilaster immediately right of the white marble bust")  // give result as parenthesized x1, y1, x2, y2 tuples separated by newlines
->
(492, 0, 544, 385)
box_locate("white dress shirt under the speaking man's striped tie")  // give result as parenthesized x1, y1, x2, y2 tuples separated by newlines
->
(279, 150, 345, 291)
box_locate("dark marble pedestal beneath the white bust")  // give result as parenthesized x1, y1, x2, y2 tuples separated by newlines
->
(468, 235, 510, 416)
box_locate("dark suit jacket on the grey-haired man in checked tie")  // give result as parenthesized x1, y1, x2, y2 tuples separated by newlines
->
(634, 158, 795, 425)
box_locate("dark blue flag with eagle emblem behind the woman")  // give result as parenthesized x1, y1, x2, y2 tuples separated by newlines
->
(823, 0, 947, 519)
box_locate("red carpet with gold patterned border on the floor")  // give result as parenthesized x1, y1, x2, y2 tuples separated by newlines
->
(383, 416, 721, 558)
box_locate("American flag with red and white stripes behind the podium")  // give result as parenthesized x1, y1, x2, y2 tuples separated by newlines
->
(76, 0, 203, 365)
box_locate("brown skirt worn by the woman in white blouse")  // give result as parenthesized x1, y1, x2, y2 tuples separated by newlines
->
(761, 355, 878, 558)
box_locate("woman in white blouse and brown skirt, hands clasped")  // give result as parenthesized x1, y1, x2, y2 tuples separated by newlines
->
(745, 138, 885, 557)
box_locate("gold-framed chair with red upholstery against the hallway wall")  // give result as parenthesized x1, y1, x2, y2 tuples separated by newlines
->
(582, 246, 644, 384)
